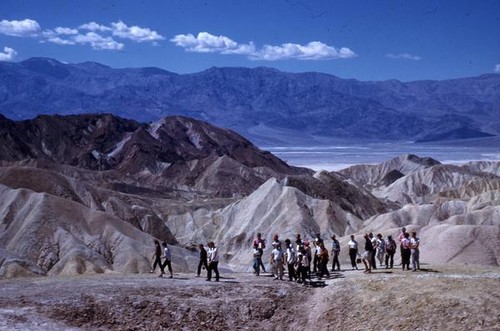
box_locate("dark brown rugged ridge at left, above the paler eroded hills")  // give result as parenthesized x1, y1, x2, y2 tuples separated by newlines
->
(0, 115, 311, 196)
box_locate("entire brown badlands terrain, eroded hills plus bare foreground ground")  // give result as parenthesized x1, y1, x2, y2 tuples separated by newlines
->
(0, 114, 500, 330)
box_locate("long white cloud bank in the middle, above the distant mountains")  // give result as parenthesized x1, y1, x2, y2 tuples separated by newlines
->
(170, 32, 356, 61)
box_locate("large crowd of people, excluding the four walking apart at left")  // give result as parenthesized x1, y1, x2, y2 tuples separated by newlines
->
(253, 228, 420, 284)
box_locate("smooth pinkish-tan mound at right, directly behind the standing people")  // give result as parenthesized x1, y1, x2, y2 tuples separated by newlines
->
(359, 201, 500, 266)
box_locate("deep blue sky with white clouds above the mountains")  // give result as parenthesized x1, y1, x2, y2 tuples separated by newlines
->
(0, 0, 500, 81)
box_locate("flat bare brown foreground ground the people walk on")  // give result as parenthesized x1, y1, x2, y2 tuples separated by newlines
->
(0, 266, 500, 330)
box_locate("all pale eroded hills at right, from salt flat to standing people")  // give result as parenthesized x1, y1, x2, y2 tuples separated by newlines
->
(336, 155, 500, 266)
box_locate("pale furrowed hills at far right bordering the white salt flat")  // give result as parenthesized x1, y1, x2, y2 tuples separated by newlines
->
(339, 155, 500, 205)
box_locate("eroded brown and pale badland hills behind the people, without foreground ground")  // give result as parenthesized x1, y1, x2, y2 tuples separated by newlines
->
(0, 115, 500, 277)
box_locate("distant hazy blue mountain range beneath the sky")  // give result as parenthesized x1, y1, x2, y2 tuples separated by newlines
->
(0, 58, 500, 144)
